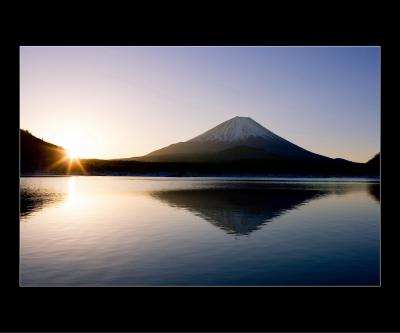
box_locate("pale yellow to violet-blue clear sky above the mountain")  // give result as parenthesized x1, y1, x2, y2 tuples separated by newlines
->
(20, 46, 380, 162)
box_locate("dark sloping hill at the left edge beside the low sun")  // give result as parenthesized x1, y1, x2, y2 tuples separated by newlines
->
(20, 129, 66, 173)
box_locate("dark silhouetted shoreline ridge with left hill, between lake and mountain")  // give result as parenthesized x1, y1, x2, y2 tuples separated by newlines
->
(20, 130, 380, 177)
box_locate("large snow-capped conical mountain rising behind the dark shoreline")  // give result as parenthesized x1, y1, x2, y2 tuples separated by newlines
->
(130, 117, 332, 162)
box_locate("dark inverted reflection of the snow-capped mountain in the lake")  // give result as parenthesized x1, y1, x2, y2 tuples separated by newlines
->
(150, 183, 366, 235)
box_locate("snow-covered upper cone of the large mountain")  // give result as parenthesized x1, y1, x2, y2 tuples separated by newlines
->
(189, 116, 275, 142)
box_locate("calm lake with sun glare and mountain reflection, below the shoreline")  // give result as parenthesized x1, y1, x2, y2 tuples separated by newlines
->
(20, 176, 380, 286)
